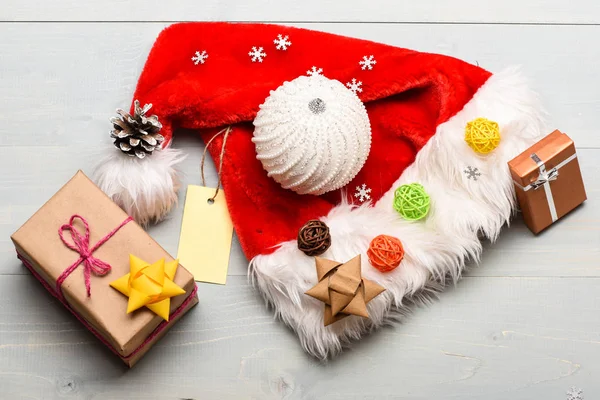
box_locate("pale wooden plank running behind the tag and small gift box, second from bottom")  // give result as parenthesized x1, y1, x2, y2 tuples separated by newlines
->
(0, 144, 600, 276)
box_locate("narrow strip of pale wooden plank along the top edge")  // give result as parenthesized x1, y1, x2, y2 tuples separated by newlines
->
(0, 0, 600, 24)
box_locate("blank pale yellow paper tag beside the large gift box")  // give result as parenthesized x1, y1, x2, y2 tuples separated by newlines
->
(177, 185, 233, 285)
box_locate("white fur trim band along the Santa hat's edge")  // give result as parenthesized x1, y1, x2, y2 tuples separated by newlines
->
(249, 68, 546, 358)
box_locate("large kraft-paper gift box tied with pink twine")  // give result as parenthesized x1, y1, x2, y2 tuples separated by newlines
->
(11, 171, 198, 367)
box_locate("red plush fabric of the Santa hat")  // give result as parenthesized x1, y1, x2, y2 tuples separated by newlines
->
(134, 22, 490, 258)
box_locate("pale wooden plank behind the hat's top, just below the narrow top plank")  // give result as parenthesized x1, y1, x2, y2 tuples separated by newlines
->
(0, 23, 600, 151)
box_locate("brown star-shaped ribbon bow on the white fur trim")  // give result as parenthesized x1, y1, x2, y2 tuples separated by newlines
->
(306, 254, 385, 326)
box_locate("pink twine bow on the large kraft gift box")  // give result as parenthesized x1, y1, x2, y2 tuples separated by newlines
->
(56, 215, 132, 297)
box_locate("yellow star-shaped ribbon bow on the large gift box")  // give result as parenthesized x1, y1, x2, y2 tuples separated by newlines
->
(110, 254, 185, 321)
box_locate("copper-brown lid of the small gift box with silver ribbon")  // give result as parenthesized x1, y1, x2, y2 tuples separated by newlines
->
(508, 130, 575, 187)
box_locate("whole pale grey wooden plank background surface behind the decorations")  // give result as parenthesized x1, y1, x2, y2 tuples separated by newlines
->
(0, 0, 600, 400)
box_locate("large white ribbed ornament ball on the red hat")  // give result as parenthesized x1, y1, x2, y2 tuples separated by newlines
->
(252, 75, 371, 195)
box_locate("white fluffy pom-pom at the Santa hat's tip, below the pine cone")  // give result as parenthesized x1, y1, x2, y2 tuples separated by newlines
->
(94, 148, 185, 225)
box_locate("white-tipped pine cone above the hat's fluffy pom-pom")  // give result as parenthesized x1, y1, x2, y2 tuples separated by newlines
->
(110, 100, 165, 158)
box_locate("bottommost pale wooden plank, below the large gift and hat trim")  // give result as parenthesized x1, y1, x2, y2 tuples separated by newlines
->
(0, 276, 600, 400)
